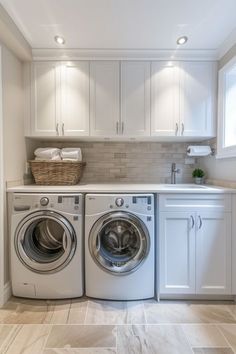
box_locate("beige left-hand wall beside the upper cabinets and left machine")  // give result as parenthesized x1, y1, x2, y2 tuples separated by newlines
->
(2, 46, 26, 290)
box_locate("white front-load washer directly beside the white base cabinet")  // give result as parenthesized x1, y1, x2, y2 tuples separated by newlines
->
(85, 194, 154, 300)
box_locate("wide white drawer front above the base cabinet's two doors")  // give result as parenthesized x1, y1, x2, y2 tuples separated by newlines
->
(159, 194, 231, 212)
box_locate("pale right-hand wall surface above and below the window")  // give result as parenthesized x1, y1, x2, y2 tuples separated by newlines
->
(201, 44, 236, 183)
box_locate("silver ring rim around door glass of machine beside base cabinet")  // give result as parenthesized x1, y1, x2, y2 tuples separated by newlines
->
(88, 211, 150, 276)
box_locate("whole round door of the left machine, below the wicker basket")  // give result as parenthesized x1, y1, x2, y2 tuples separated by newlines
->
(15, 211, 76, 273)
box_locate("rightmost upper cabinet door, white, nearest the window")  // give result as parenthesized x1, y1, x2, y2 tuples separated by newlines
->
(180, 62, 216, 137)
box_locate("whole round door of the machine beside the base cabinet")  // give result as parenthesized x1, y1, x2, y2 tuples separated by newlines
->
(89, 212, 150, 275)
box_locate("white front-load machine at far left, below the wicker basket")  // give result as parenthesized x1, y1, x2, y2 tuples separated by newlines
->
(9, 193, 83, 299)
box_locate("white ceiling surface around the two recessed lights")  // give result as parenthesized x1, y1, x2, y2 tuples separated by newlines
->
(0, 0, 236, 49)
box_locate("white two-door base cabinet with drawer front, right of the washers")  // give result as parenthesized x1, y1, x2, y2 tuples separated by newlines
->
(158, 195, 232, 295)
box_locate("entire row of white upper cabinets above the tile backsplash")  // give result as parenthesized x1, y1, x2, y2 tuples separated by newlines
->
(25, 60, 216, 140)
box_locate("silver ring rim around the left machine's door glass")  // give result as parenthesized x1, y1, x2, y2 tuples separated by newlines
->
(14, 210, 77, 274)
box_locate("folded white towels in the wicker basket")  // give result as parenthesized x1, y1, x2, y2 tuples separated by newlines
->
(34, 148, 82, 162)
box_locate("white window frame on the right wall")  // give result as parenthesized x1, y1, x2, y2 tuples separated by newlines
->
(216, 56, 236, 159)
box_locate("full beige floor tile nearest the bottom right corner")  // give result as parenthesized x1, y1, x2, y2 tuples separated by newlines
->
(182, 324, 228, 347)
